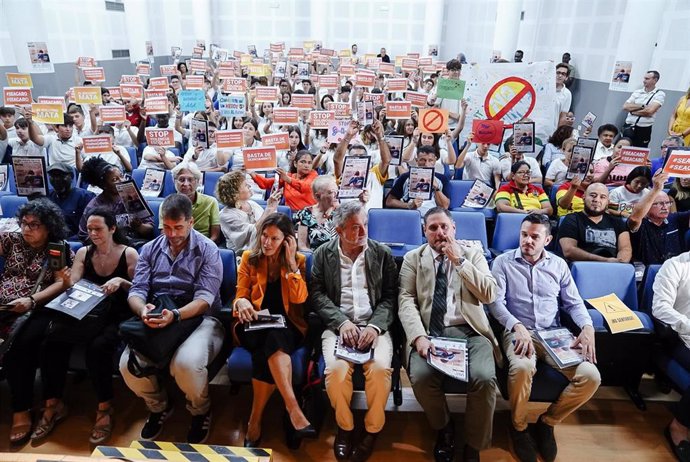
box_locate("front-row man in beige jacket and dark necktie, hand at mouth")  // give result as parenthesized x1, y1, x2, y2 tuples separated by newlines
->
(398, 207, 502, 461)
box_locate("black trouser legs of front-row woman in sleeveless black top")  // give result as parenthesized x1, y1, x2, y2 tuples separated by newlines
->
(41, 323, 120, 403)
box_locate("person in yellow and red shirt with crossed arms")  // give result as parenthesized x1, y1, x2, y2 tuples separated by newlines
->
(495, 160, 553, 215)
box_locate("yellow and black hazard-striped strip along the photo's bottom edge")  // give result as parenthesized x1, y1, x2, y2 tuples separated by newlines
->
(91, 446, 271, 462)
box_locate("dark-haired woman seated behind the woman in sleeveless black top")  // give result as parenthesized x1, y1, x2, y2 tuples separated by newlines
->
(79, 157, 153, 247)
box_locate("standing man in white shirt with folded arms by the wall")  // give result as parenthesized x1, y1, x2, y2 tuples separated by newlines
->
(623, 71, 666, 148)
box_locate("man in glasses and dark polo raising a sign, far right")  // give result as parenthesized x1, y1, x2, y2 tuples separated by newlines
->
(627, 171, 690, 265)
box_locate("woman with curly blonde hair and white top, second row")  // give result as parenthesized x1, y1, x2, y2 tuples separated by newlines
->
(216, 172, 282, 253)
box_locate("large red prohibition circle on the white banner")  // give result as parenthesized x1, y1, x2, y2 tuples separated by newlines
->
(484, 77, 537, 126)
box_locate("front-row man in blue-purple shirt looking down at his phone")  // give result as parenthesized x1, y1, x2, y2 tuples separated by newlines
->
(120, 194, 224, 443)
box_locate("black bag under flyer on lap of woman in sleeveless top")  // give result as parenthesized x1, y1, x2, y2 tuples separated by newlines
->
(46, 297, 112, 344)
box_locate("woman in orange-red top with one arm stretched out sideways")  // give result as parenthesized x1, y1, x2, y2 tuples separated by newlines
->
(249, 150, 319, 212)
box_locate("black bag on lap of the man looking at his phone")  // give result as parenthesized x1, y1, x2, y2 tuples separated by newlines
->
(120, 295, 203, 377)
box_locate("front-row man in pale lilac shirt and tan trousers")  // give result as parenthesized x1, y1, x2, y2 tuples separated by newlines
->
(489, 214, 601, 462)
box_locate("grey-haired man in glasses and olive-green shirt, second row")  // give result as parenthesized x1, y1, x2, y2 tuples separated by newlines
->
(158, 161, 220, 243)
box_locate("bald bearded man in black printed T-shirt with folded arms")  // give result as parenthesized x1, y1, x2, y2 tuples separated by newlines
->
(558, 183, 632, 263)
